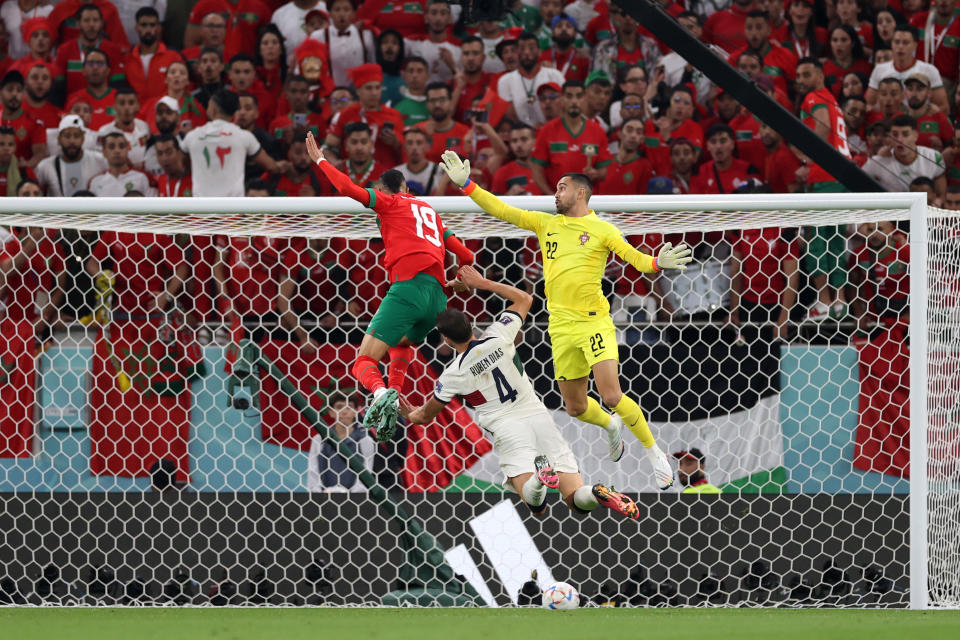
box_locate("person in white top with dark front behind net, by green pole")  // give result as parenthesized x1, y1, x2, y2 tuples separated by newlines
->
(307, 393, 377, 493)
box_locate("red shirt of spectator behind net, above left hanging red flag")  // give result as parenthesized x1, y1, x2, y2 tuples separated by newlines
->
(93, 231, 184, 316)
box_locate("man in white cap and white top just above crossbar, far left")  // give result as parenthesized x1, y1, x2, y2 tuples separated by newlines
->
(37, 115, 107, 197)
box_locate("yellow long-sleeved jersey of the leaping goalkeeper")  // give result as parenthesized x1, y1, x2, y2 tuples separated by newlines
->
(465, 182, 657, 320)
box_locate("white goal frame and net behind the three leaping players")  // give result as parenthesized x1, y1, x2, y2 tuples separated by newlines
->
(0, 194, 960, 608)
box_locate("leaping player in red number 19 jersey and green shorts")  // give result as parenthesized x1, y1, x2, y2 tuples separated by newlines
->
(307, 133, 473, 442)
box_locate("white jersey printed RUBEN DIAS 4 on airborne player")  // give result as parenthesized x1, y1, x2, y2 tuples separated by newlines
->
(434, 311, 549, 437)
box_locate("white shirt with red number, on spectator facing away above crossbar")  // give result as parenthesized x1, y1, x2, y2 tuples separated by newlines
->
(180, 120, 260, 198)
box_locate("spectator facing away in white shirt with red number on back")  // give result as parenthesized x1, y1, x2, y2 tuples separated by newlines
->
(180, 89, 289, 198)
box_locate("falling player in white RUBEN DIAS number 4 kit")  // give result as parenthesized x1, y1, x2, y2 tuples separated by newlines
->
(400, 265, 640, 518)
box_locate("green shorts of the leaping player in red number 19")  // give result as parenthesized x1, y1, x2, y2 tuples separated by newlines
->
(367, 273, 447, 347)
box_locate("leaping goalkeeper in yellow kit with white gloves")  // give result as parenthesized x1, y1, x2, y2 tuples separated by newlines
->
(440, 150, 692, 489)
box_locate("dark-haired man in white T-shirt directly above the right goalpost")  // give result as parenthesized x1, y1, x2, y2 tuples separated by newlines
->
(863, 114, 947, 199)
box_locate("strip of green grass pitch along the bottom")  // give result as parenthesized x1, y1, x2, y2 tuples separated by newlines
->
(0, 608, 960, 640)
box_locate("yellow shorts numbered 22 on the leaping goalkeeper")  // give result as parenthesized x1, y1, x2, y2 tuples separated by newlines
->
(549, 315, 620, 380)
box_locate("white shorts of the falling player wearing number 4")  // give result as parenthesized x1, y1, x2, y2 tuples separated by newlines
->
(490, 413, 580, 487)
